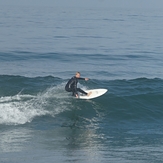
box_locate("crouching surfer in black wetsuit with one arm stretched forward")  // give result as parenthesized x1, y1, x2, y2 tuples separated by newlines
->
(65, 72, 92, 98)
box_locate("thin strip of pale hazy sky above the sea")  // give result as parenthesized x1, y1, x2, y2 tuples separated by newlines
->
(0, 0, 163, 8)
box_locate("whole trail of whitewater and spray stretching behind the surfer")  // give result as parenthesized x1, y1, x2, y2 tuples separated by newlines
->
(0, 84, 70, 125)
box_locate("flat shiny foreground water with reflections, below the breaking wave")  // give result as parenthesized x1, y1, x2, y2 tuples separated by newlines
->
(0, 123, 163, 163)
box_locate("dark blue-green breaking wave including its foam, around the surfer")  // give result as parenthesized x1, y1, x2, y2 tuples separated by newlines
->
(0, 75, 163, 126)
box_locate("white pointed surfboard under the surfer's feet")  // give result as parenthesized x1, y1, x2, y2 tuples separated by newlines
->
(79, 89, 108, 99)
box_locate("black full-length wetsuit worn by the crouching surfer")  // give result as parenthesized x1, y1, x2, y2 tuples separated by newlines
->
(65, 76, 87, 96)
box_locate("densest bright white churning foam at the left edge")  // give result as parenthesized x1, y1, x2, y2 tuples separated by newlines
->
(0, 97, 48, 124)
